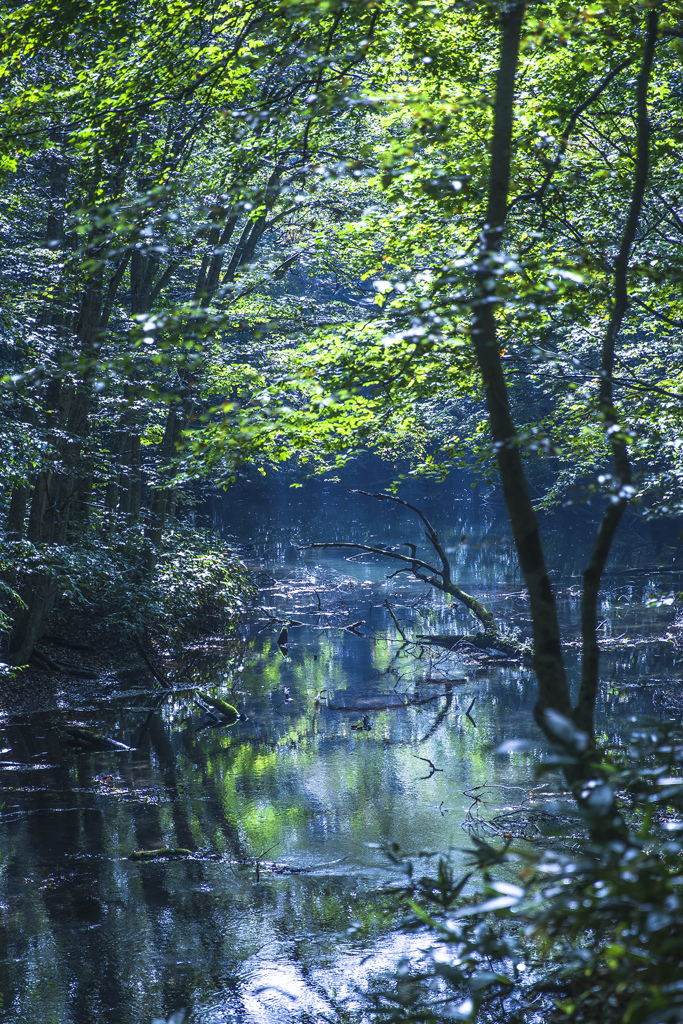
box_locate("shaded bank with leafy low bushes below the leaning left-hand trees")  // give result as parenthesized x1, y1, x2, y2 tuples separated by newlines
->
(2, 525, 255, 713)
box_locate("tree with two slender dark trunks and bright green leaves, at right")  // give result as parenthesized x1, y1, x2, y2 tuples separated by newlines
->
(278, 3, 681, 782)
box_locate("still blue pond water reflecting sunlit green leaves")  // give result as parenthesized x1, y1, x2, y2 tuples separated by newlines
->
(0, 473, 682, 1024)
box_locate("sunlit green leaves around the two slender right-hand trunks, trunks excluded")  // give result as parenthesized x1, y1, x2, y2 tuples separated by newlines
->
(278, 3, 683, 514)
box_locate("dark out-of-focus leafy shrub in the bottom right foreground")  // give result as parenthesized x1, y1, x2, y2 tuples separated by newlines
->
(371, 722, 683, 1024)
